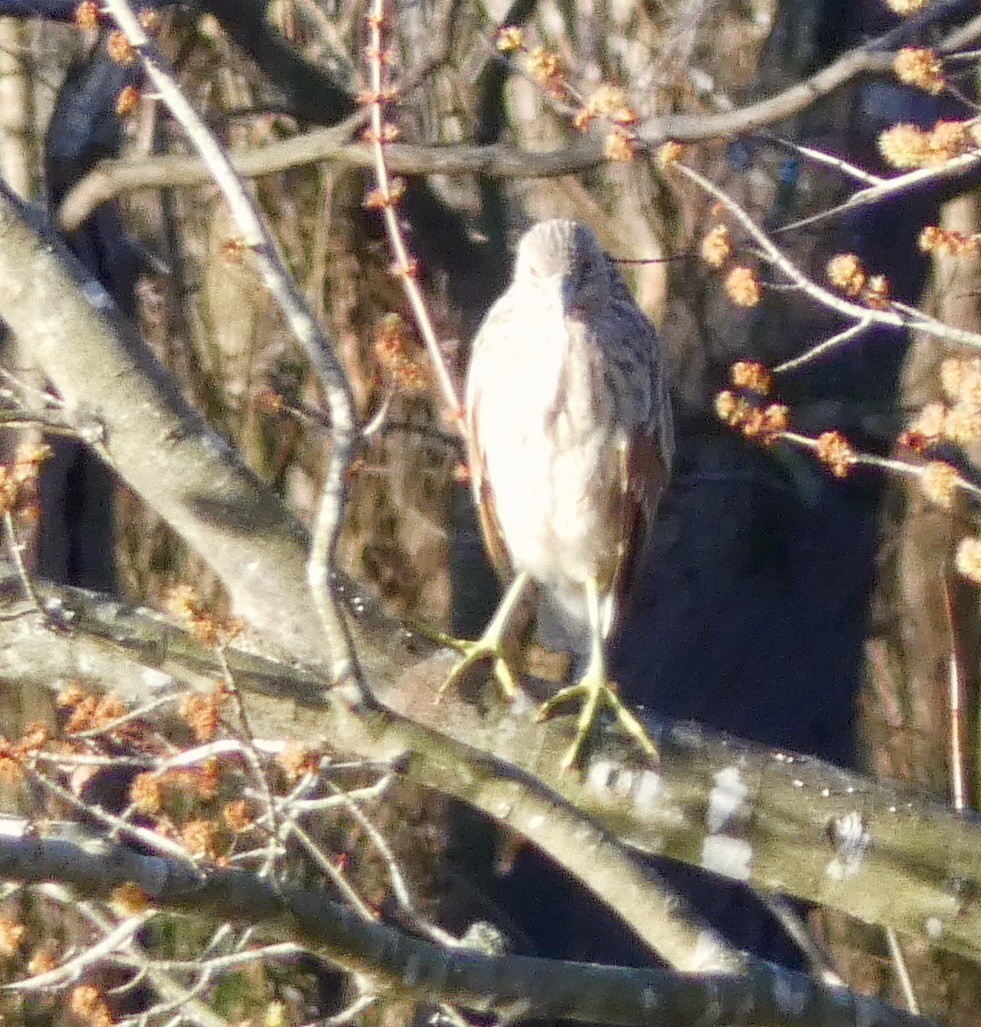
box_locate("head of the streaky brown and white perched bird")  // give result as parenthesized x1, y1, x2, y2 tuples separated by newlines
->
(515, 219, 611, 315)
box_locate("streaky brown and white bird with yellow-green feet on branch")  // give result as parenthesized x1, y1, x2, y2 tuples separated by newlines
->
(440, 219, 674, 770)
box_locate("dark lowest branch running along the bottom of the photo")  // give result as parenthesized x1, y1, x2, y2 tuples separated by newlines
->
(0, 822, 925, 1027)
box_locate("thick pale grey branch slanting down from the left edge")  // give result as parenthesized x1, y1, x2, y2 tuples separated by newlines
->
(0, 186, 325, 664)
